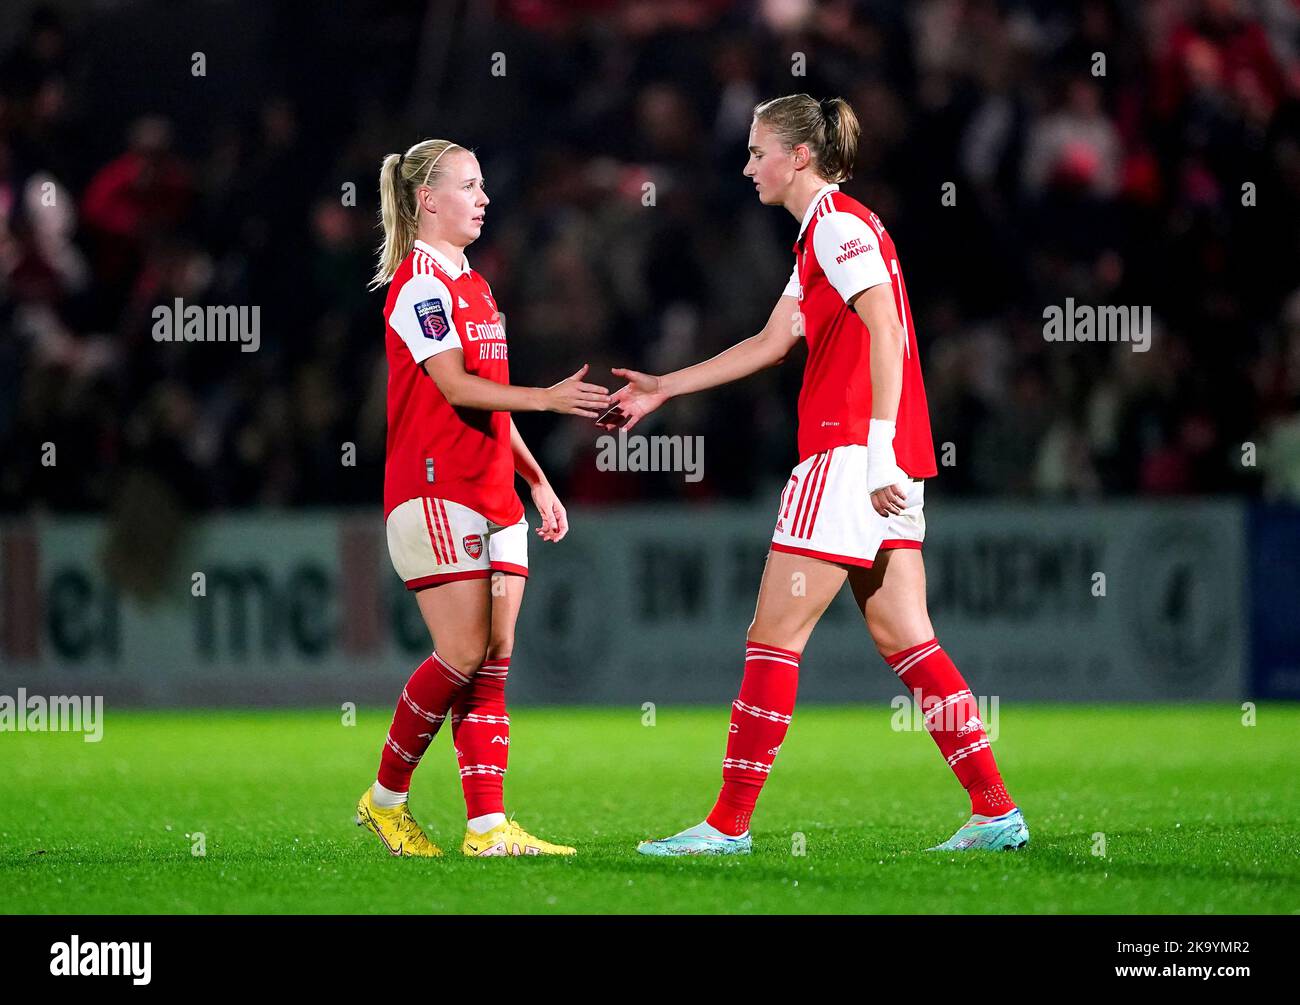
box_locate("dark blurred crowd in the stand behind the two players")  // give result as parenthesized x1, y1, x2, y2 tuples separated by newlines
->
(0, 0, 1300, 511)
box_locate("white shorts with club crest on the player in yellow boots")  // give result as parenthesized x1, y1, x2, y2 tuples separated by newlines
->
(387, 497, 528, 590)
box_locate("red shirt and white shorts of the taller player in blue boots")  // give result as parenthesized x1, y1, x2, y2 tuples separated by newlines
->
(772, 185, 937, 567)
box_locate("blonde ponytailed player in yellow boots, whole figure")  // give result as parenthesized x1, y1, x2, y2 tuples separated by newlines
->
(356, 139, 610, 857)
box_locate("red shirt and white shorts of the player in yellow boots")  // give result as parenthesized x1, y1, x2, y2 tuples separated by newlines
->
(384, 241, 528, 590)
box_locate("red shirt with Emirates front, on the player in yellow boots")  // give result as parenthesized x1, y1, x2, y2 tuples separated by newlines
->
(384, 241, 524, 524)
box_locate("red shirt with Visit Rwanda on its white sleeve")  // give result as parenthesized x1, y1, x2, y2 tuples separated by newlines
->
(784, 185, 939, 478)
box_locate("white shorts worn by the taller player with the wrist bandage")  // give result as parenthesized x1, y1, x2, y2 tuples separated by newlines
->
(772, 443, 926, 568)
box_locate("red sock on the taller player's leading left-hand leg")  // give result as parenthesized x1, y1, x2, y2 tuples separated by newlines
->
(709, 642, 800, 835)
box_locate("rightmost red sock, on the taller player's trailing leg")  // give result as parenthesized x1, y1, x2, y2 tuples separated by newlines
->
(885, 638, 1015, 816)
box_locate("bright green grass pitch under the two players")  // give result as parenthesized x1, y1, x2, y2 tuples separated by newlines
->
(0, 705, 1300, 914)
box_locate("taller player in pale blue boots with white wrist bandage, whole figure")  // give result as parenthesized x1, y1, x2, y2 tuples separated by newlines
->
(602, 95, 1030, 855)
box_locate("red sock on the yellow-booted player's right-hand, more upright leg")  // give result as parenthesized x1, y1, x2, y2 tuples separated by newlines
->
(451, 657, 510, 819)
